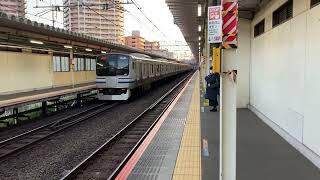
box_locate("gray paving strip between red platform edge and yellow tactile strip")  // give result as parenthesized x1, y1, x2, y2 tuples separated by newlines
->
(127, 75, 195, 180)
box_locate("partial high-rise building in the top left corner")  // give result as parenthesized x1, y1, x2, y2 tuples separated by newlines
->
(0, 0, 26, 17)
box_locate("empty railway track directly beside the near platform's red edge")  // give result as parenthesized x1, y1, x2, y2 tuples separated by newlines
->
(62, 75, 191, 180)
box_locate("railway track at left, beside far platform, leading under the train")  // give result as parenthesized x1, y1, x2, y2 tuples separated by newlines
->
(0, 103, 118, 161)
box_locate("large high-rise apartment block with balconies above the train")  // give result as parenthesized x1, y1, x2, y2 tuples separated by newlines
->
(63, 0, 124, 44)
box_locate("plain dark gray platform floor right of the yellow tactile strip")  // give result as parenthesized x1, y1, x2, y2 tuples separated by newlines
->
(201, 104, 320, 180)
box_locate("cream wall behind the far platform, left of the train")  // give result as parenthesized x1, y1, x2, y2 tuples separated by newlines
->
(0, 51, 96, 95)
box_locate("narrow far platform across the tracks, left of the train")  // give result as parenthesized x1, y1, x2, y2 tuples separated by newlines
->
(0, 82, 96, 109)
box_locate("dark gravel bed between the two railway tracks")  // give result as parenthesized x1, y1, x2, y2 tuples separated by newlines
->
(0, 74, 190, 180)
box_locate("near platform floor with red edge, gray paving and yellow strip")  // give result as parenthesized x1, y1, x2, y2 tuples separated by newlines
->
(116, 72, 320, 180)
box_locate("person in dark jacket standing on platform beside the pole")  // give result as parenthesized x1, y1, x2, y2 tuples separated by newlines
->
(205, 67, 220, 112)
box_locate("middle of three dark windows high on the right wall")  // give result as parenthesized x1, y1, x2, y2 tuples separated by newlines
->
(272, 0, 293, 27)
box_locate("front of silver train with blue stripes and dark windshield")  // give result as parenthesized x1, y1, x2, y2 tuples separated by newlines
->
(96, 54, 135, 100)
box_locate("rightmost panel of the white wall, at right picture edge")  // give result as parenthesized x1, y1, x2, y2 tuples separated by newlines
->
(303, 6, 320, 155)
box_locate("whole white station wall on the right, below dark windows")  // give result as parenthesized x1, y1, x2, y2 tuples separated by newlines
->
(250, 0, 320, 156)
